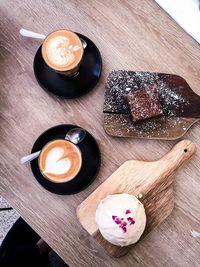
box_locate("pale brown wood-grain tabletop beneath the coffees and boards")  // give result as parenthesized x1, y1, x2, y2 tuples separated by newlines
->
(0, 0, 200, 267)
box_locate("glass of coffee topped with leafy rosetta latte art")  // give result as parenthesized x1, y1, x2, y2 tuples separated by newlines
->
(42, 30, 84, 76)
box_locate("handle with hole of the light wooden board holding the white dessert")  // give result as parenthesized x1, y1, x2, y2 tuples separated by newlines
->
(159, 140, 196, 176)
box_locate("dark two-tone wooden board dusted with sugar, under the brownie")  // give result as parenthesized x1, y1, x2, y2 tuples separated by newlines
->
(104, 70, 200, 140)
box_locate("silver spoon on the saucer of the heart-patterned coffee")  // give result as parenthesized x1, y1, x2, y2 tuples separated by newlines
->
(20, 128, 86, 164)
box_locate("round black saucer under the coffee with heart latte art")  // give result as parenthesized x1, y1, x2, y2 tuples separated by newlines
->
(31, 124, 101, 195)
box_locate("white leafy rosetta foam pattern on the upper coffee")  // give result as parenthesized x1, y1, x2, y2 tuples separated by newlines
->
(46, 36, 81, 66)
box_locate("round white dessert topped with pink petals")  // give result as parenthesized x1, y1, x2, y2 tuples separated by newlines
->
(96, 194, 146, 247)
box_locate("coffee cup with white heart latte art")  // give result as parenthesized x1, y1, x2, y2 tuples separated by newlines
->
(39, 139, 82, 183)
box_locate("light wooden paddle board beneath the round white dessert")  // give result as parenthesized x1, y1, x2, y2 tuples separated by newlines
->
(77, 140, 196, 257)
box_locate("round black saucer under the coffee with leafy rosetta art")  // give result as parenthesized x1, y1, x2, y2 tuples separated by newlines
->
(33, 33, 102, 98)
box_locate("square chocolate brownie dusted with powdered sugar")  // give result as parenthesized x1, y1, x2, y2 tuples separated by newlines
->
(127, 85, 162, 122)
